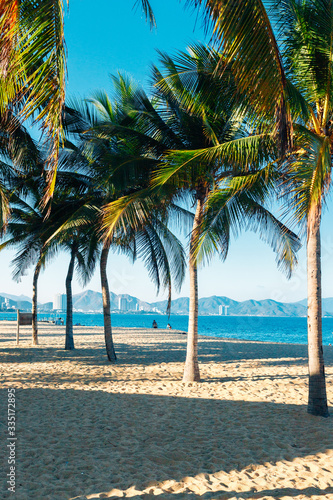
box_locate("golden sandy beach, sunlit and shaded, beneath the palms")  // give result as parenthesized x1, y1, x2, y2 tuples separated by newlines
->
(0, 322, 333, 500)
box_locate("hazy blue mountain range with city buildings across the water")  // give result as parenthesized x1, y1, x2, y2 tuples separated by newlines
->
(0, 290, 333, 317)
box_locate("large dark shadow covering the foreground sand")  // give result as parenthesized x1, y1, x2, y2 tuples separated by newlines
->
(1, 388, 333, 500)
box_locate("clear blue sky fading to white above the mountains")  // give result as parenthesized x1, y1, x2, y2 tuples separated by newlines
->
(0, 0, 333, 302)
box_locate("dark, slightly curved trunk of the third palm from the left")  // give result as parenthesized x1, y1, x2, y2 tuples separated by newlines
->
(100, 241, 117, 362)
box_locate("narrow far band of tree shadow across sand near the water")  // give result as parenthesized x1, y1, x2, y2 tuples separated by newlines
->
(0, 333, 333, 374)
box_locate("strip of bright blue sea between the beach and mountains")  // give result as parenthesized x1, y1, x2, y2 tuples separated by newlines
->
(0, 313, 333, 345)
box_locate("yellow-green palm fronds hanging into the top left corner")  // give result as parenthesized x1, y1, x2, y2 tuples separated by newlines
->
(0, 0, 156, 203)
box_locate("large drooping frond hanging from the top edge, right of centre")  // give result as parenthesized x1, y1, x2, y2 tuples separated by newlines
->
(187, 0, 291, 152)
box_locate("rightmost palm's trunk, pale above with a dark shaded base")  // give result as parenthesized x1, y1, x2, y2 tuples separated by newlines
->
(307, 203, 328, 417)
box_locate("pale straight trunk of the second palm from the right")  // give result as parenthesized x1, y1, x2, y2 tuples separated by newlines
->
(183, 199, 203, 382)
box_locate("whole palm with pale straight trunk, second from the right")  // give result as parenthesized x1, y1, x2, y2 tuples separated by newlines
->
(153, 46, 299, 381)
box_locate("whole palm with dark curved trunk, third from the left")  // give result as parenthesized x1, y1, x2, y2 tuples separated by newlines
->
(59, 97, 185, 362)
